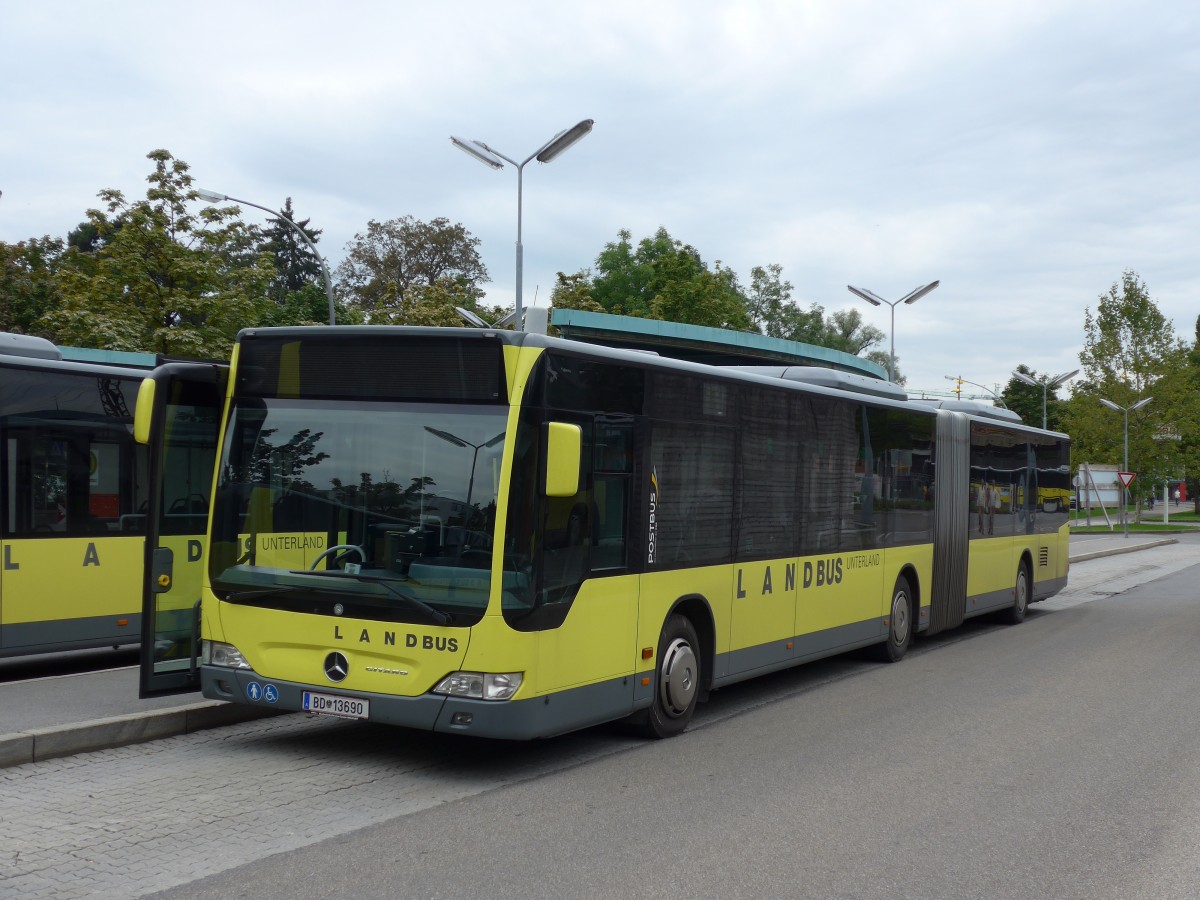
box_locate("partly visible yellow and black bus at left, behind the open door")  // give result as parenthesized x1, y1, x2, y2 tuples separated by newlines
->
(0, 334, 215, 658)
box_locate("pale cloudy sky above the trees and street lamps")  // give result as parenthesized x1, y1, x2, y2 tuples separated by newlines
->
(0, 0, 1200, 397)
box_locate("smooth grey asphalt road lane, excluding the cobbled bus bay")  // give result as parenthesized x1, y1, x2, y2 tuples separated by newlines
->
(147, 548, 1200, 900)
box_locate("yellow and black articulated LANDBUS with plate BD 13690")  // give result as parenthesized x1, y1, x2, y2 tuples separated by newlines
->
(137, 326, 1069, 738)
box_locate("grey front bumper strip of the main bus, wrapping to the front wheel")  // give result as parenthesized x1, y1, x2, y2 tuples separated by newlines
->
(200, 666, 635, 740)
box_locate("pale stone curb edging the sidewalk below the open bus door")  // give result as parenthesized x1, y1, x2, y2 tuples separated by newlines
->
(0, 700, 277, 768)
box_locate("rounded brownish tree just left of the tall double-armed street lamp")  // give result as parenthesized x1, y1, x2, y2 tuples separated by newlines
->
(337, 216, 488, 324)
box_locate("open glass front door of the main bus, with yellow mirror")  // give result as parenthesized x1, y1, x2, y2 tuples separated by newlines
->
(133, 362, 229, 698)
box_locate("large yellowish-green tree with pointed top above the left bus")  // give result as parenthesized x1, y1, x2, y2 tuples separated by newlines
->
(40, 150, 271, 358)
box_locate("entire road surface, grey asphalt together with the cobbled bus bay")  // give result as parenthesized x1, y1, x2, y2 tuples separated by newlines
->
(0, 542, 1200, 900)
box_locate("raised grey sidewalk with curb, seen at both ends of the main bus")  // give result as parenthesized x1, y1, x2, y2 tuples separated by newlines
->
(0, 532, 1176, 768)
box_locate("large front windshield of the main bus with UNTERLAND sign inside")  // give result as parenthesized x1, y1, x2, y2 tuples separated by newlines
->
(210, 398, 508, 624)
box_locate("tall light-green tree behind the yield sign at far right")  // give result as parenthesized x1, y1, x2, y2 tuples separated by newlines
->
(1064, 270, 1200, 504)
